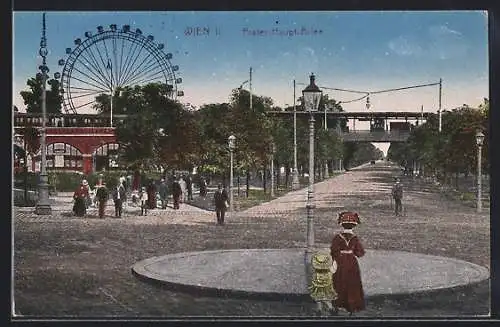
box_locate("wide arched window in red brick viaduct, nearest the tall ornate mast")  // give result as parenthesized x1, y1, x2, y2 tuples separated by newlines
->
(47, 143, 83, 170)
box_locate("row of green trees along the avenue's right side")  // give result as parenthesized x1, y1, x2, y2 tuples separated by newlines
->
(388, 99, 490, 182)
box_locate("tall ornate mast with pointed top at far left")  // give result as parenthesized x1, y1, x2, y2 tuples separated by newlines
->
(35, 13, 52, 215)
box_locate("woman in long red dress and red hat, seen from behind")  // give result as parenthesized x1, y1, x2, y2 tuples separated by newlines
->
(330, 212, 365, 316)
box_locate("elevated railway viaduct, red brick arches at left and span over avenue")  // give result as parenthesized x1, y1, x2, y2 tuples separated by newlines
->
(13, 111, 431, 174)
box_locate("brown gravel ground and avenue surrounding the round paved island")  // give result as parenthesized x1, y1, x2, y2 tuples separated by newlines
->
(14, 163, 490, 317)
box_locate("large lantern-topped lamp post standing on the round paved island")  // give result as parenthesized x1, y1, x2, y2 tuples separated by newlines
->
(302, 74, 322, 274)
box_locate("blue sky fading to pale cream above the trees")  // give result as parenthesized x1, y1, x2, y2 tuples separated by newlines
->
(13, 11, 489, 156)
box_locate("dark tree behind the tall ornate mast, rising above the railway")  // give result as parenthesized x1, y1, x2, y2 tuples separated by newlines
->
(20, 74, 63, 113)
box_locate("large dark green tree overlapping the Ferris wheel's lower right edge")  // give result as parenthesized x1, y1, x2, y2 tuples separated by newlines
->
(112, 83, 199, 169)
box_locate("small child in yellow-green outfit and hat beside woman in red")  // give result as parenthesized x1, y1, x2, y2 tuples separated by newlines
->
(309, 253, 337, 315)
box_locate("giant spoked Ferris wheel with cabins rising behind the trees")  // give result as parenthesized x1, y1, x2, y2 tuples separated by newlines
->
(54, 24, 184, 113)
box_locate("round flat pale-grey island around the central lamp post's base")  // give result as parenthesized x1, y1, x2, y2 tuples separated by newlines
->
(132, 248, 489, 299)
